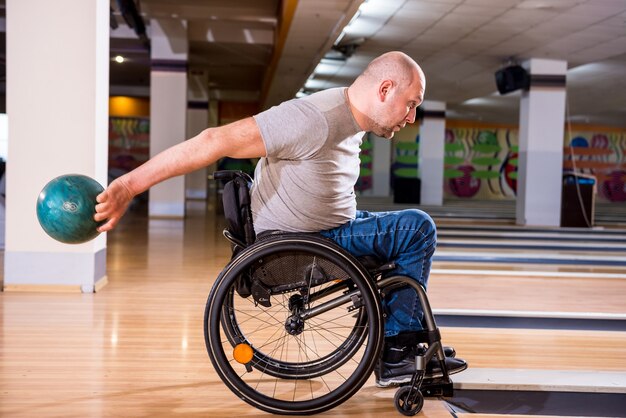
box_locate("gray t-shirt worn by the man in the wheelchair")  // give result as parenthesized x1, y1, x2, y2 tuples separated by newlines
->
(252, 88, 364, 234)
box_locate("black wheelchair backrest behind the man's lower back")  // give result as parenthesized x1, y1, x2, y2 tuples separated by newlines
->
(213, 170, 256, 248)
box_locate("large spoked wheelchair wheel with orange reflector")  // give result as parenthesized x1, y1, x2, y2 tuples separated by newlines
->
(205, 235, 383, 414)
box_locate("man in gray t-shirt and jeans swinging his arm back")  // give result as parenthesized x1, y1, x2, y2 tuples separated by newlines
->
(95, 51, 467, 386)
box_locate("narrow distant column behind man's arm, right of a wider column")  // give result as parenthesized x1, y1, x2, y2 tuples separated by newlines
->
(185, 72, 209, 200)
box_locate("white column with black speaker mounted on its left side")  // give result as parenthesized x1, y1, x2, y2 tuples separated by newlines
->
(516, 59, 567, 226)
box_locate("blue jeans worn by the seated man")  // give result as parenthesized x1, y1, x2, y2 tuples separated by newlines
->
(321, 209, 437, 337)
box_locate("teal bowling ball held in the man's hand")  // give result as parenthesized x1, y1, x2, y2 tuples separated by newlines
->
(37, 174, 104, 244)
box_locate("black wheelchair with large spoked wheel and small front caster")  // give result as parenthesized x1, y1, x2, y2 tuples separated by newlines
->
(204, 170, 452, 416)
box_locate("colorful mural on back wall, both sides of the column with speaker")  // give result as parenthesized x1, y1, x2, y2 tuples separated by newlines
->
(444, 127, 626, 202)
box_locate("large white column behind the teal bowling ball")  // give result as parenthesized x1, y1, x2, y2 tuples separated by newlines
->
(4, 0, 109, 292)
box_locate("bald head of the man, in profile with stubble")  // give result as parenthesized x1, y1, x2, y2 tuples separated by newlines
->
(347, 51, 426, 138)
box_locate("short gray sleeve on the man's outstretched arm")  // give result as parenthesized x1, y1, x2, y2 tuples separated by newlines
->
(254, 99, 328, 160)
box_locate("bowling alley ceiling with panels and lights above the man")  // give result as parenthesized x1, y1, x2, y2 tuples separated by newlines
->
(110, 0, 626, 128)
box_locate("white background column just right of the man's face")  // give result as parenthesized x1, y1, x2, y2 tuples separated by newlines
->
(419, 100, 446, 206)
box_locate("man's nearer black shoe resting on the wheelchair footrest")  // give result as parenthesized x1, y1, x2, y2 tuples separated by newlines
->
(374, 346, 467, 387)
